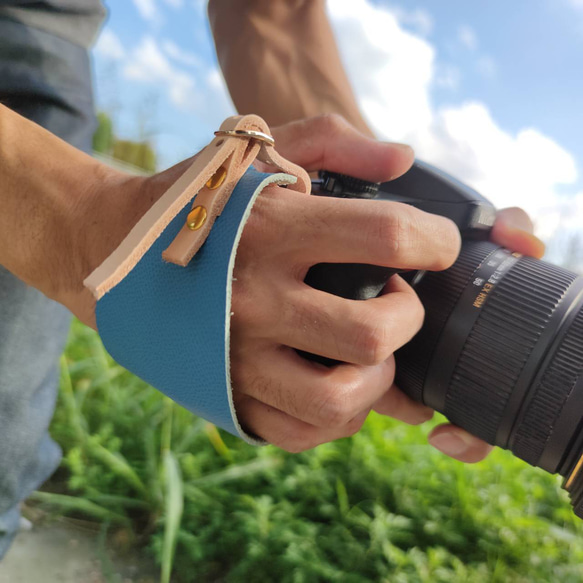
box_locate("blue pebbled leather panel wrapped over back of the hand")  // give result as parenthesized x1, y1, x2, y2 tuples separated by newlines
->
(96, 169, 296, 444)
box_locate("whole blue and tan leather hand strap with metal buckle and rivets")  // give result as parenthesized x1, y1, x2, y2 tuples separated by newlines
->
(85, 116, 311, 444)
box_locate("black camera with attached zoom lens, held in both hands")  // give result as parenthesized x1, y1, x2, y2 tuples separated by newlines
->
(305, 161, 583, 518)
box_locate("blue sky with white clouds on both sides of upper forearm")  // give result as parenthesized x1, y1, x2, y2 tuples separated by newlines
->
(94, 0, 583, 258)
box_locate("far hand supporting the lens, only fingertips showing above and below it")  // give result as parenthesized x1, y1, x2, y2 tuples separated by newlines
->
(429, 207, 545, 463)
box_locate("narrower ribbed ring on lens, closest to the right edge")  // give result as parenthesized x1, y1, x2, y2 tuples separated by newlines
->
(512, 311, 583, 466)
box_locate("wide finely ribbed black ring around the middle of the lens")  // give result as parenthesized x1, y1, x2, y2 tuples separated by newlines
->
(444, 257, 576, 444)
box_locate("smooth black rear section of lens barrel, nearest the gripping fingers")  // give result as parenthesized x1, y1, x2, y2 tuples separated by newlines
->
(396, 242, 498, 402)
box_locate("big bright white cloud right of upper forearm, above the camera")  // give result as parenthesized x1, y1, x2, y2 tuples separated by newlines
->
(328, 0, 583, 236)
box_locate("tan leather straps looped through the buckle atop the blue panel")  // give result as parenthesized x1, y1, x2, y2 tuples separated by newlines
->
(83, 115, 310, 300)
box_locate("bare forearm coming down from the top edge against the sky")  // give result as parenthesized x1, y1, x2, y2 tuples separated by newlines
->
(208, 0, 372, 135)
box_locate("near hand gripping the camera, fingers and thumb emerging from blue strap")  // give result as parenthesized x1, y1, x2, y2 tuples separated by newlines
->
(231, 116, 460, 452)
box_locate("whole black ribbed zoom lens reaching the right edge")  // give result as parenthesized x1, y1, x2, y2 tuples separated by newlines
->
(396, 242, 583, 518)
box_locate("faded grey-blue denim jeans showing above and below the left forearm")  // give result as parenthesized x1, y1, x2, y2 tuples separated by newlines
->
(0, 19, 95, 559)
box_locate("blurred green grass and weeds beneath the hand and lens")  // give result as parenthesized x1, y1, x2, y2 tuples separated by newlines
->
(35, 323, 583, 583)
